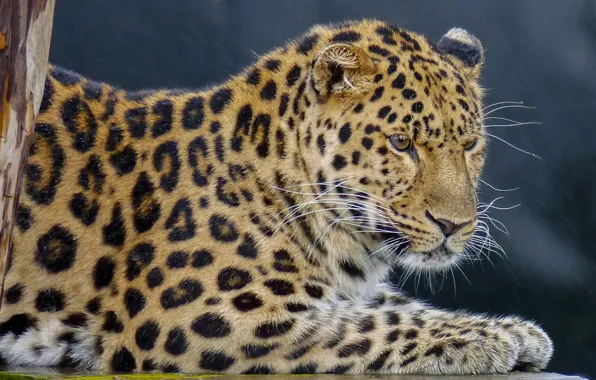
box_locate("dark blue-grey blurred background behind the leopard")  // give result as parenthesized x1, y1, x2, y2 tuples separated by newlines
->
(50, 0, 596, 379)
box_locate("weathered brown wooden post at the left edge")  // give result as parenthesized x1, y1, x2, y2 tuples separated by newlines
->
(0, 0, 54, 307)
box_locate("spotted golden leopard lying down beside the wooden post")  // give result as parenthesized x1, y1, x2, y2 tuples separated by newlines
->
(0, 19, 553, 375)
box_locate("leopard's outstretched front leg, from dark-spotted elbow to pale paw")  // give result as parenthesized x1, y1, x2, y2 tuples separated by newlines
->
(95, 246, 552, 374)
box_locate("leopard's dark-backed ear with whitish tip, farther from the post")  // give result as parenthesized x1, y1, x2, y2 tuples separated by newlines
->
(437, 28, 484, 79)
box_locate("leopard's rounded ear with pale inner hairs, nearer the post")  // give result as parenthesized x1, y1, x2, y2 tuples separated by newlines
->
(312, 43, 376, 99)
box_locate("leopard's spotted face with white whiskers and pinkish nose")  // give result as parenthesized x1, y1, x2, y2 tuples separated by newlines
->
(304, 25, 486, 270)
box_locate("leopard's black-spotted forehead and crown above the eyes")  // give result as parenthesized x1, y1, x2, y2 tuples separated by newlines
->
(297, 20, 482, 145)
